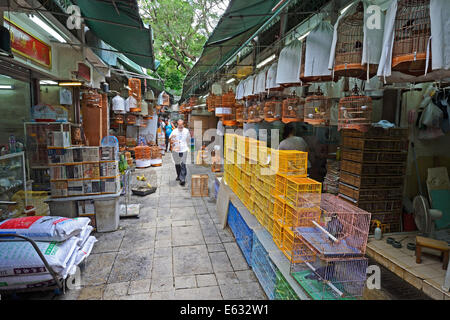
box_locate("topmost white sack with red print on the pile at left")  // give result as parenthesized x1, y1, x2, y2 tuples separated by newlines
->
(0, 216, 91, 241)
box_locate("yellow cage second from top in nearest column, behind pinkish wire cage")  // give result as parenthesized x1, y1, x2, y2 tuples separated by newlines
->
(283, 203, 321, 228)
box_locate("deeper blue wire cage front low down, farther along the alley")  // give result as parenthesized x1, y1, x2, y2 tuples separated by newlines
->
(227, 201, 253, 266)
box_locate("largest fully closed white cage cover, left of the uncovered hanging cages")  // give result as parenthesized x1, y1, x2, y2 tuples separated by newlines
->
(303, 21, 333, 77)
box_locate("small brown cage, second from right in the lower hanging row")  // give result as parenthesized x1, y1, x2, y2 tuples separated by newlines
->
(303, 87, 331, 125)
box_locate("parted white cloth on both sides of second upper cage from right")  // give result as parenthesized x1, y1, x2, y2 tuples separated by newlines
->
(328, 0, 391, 76)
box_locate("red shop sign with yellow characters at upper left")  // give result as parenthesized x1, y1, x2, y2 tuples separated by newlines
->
(5, 19, 52, 69)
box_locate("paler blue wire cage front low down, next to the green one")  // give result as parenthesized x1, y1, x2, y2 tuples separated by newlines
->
(252, 234, 277, 300)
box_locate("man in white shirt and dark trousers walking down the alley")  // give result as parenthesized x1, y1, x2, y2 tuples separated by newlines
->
(169, 119, 191, 186)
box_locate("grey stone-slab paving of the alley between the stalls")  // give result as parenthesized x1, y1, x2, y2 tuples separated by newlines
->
(49, 154, 267, 300)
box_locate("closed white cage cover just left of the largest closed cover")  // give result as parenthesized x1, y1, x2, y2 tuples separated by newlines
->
(276, 40, 302, 84)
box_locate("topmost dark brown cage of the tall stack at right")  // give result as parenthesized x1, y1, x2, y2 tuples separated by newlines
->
(342, 136, 408, 151)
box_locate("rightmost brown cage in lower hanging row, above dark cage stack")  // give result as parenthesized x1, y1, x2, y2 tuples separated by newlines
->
(338, 84, 372, 132)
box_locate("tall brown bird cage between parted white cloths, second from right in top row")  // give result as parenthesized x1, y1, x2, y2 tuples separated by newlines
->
(334, 2, 377, 79)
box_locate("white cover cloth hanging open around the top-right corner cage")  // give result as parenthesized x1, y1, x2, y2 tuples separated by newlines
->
(377, 0, 450, 81)
